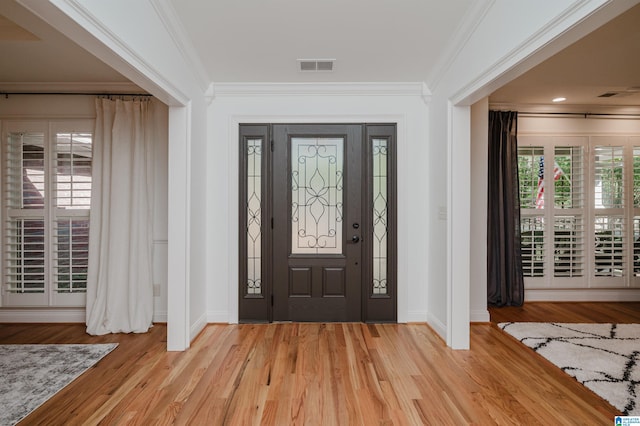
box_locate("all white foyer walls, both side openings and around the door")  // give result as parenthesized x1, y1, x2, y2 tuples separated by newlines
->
(18, 0, 634, 350)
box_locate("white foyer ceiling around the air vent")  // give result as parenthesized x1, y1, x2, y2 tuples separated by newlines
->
(166, 0, 477, 82)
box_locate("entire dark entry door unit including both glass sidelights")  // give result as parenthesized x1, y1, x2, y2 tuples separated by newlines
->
(239, 124, 396, 322)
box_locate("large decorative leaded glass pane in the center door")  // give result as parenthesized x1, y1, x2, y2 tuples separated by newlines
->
(291, 138, 344, 254)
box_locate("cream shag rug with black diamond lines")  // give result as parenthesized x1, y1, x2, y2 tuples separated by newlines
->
(498, 322, 640, 416)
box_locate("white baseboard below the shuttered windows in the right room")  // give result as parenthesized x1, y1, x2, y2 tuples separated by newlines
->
(524, 288, 640, 302)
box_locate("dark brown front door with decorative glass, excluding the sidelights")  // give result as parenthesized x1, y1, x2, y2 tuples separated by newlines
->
(273, 125, 363, 321)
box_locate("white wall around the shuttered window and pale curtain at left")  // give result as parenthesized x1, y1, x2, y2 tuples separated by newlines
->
(0, 95, 168, 322)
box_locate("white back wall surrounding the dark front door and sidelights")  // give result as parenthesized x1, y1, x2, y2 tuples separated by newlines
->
(206, 85, 430, 322)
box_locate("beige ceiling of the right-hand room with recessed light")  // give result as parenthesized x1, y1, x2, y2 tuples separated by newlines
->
(489, 5, 640, 106)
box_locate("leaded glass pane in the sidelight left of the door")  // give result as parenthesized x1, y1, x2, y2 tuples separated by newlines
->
(246, 139, 263, 295)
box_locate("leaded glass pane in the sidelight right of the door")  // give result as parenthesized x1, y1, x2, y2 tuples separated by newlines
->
(372, 139, 389, 295)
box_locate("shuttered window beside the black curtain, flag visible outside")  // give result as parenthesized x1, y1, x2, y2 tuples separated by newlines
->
(518, 137, 588, 288)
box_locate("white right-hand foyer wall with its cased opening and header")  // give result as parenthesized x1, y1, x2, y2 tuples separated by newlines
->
(428, 0, 631, 349)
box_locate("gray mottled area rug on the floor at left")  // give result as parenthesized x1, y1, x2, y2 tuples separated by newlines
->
(0, 343, 118, 426)
